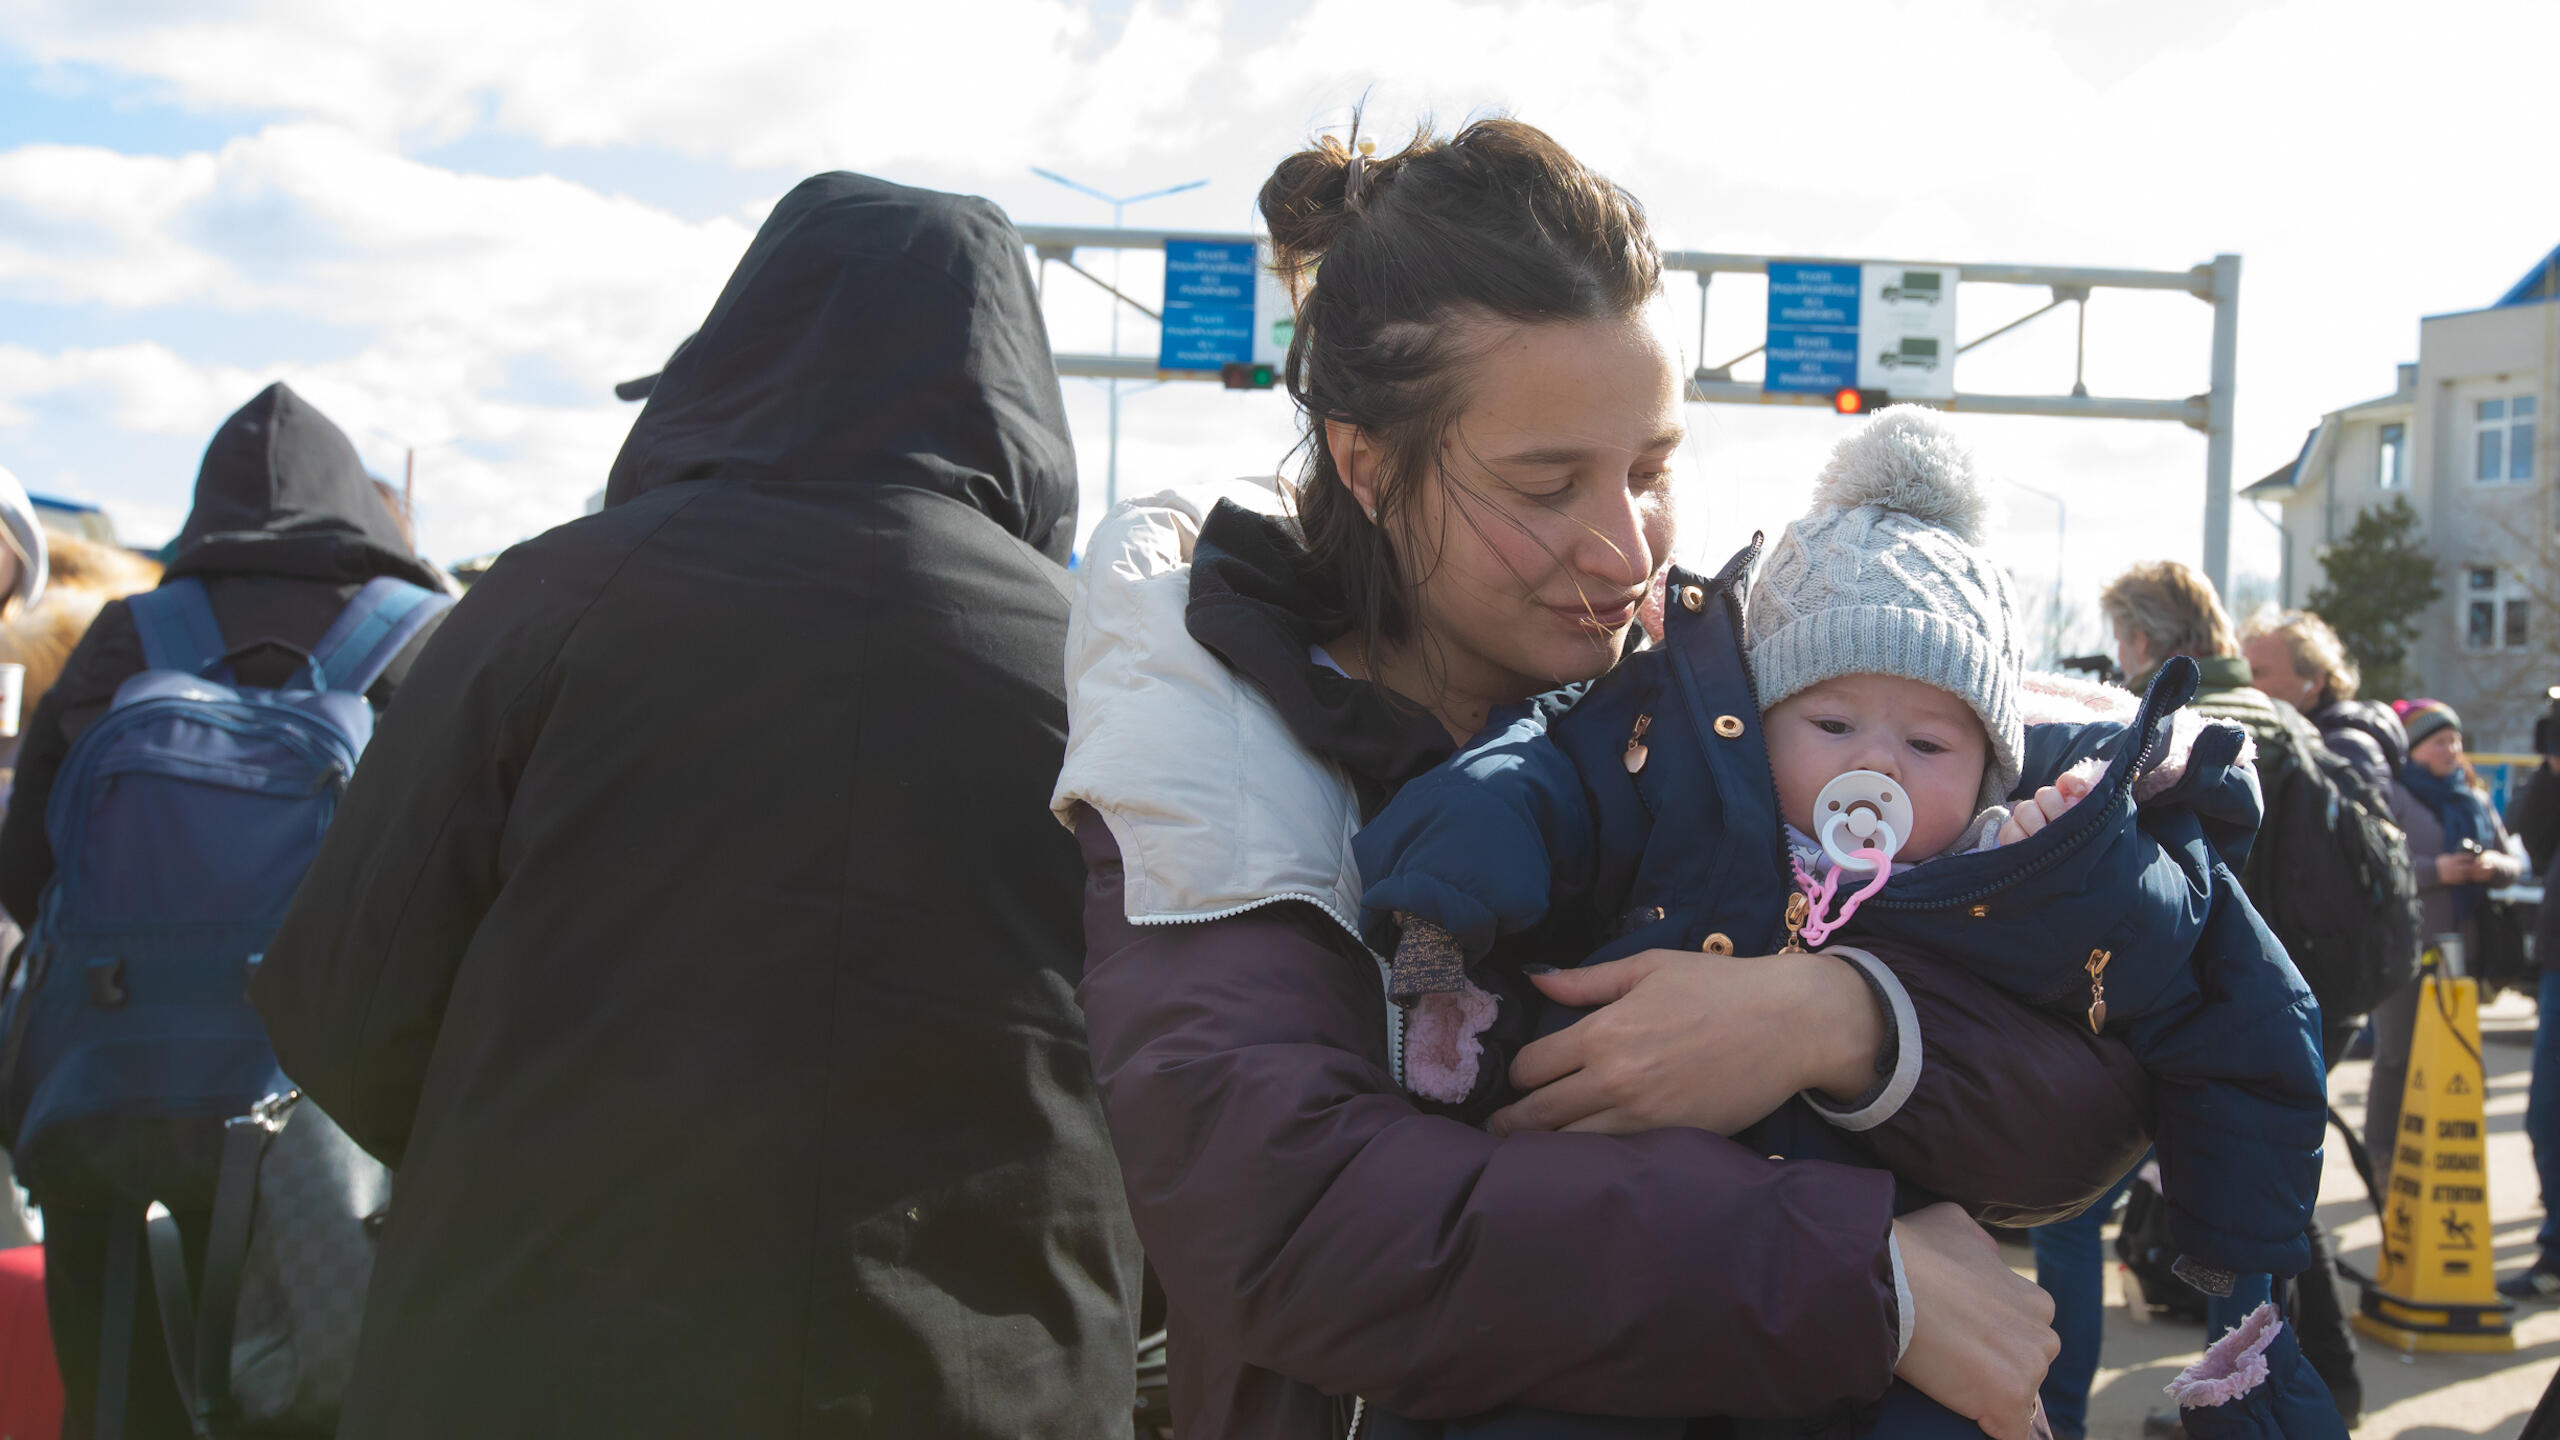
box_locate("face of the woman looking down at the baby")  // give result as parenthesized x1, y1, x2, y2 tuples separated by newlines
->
(1398, 318, 1684, 705)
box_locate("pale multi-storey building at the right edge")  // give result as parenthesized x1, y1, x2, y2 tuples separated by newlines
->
(2243, 249, 2560, 753)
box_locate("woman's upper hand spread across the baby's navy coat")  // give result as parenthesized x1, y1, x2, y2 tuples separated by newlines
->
(1492, 951, 1884, 1135)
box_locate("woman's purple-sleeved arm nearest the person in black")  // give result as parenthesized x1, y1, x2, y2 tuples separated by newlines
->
(1078, 815, 1914, 1417)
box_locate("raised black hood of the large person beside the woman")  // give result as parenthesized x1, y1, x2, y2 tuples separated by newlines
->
(604, 174, 1075, 564)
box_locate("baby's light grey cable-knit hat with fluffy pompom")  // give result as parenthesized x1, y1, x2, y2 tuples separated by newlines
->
(1746, 405, 2028, 805)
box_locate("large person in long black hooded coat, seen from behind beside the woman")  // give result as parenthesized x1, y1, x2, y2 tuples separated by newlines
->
(256, 174, 1139, 1440)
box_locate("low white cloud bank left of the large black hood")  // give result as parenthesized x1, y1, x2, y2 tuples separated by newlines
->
(0, 123, 750, 556)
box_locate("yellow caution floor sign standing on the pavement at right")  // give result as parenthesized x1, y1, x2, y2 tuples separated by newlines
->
(2355, 951, 2516, 1350)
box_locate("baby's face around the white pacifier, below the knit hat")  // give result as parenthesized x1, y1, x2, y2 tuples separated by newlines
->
(1761, 674, 1992, 863)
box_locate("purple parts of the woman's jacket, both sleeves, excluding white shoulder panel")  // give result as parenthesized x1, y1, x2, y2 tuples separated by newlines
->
(1075, 499, 2150, 1440)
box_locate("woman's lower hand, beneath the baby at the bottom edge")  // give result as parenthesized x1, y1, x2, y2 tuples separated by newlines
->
(1894, 1204, 2061, 1440)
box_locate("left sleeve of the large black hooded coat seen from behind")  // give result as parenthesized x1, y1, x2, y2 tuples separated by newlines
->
(251, 571, 573, 1166)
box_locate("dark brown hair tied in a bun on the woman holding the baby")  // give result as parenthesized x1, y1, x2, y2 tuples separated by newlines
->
(1260, 115, 1661, 653)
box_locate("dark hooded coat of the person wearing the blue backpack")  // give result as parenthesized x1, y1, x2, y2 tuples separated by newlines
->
(0, 384, 443, 928)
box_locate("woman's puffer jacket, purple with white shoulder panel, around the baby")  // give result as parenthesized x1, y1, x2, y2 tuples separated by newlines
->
(1060, 497, 2148, 1440)
